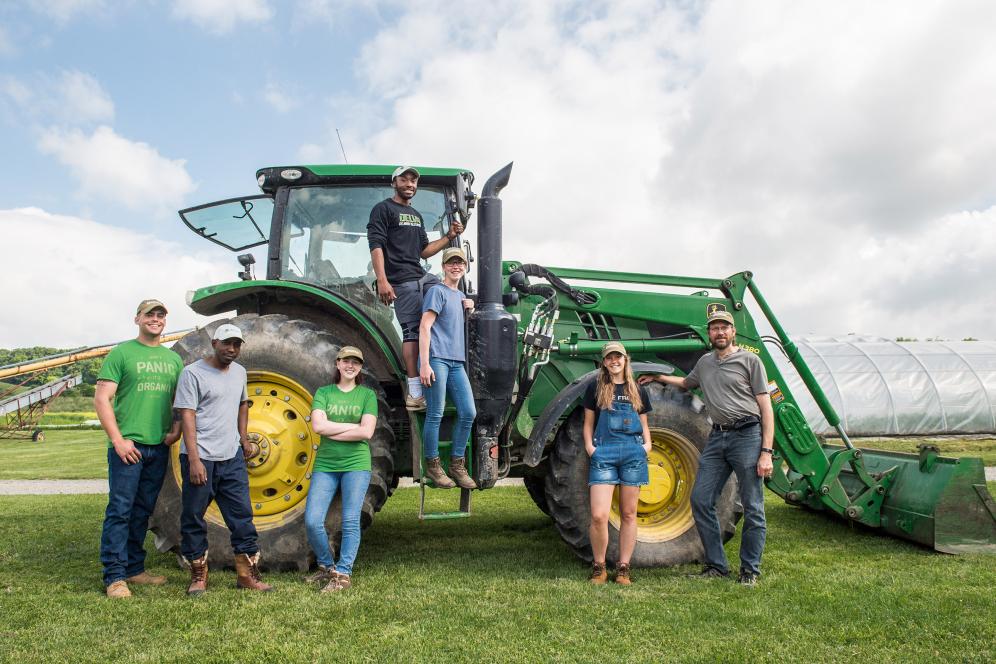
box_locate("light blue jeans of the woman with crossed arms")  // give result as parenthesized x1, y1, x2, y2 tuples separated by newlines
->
(304, 470, 370, 574)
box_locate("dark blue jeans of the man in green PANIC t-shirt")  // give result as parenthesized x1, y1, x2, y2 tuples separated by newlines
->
(100, 443, 169, 586)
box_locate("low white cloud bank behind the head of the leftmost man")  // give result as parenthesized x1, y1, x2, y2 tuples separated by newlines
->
(0, 208, 235, 348)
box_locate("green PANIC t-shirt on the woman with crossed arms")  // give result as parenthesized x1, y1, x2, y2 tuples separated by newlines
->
(311, 385, 377, 473)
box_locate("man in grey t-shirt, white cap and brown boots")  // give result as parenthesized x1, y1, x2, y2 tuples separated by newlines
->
(173, 324, 272, 596)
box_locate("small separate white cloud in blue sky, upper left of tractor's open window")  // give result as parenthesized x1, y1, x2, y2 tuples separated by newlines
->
(39, 126, 196, 214)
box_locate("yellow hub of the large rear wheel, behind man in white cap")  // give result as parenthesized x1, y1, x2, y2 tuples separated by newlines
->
(173, 371, 321, 529)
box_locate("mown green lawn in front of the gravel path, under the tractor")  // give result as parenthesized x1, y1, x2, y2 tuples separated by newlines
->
(0, 488, 996, 662)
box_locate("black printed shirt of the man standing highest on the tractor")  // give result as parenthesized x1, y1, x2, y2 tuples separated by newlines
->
(367, 198, 429, 284)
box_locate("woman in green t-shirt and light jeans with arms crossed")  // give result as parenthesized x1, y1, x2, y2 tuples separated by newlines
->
(304, 346, 377, 592)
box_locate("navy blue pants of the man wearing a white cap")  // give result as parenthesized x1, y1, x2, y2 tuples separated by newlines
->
(180, 449, 259, 560)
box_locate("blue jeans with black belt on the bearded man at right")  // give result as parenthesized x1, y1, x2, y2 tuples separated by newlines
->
(692, 425, 767, 574)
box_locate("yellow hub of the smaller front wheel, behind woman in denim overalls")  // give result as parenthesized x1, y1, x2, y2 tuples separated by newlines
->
(609, 429, 699, 542)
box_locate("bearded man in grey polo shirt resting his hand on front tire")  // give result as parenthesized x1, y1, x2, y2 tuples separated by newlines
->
(640, 309, 775, 586)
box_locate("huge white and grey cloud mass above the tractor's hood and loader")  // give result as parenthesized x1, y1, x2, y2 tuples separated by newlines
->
(320, 0, 996, 338)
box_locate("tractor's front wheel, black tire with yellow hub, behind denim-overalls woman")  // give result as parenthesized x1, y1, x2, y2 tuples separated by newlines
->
(546, 385, 743, 567)
